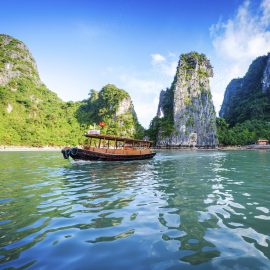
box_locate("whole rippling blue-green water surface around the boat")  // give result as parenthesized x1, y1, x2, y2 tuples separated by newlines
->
(0, 151, 270, 270)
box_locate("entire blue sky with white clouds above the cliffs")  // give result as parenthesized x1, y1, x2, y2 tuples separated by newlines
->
(0, 0, 270, 128)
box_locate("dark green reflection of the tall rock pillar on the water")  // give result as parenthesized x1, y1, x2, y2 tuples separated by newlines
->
(154, 153, 220, 265)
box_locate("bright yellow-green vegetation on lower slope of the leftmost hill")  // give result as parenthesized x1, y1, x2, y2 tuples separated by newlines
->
(0, 77, 83, 146)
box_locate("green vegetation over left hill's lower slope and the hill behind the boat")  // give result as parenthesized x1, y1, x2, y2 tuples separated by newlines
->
(0, 80, 144, 146)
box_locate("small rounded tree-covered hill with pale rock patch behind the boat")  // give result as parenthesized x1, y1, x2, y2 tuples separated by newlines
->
(77, 84, 144, 138)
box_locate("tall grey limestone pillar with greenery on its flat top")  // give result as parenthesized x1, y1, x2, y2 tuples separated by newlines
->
(154, 52, 217, 147)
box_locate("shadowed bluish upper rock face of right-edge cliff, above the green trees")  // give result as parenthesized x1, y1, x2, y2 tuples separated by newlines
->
(219, 54, 270, 126)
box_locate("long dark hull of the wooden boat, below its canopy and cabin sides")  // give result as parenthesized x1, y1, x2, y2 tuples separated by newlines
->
(62, 148, 156, 161)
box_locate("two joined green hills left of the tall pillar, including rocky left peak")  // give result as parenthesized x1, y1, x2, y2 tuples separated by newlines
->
(0, 34, 143, 146)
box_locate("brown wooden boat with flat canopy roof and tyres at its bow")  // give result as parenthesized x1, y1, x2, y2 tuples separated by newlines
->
(61, 134, 156, 161)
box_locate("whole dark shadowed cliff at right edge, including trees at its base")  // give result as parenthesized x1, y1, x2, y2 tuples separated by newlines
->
(217, 55, 270, 145)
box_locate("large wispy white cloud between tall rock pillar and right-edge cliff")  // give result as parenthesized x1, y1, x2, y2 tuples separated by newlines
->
(210, 0, 270, 114)
